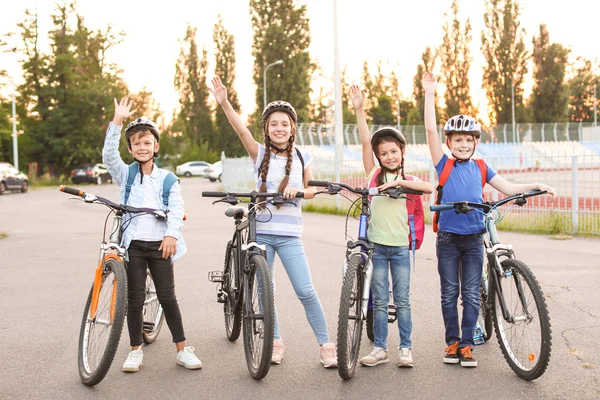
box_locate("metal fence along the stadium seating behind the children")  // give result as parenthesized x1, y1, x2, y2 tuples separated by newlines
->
(222, 140, 600, 235)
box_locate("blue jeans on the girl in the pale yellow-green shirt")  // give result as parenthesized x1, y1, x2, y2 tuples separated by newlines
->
(371, 243, 412, 349)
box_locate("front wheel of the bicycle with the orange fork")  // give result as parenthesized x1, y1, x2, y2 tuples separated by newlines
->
(78, 259, 127, 386)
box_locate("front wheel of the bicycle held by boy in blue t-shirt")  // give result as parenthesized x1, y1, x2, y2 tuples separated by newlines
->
(492, 259, 552, 381)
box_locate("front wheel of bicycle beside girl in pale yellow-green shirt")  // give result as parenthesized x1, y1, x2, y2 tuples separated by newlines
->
(337, 255, 365, 380)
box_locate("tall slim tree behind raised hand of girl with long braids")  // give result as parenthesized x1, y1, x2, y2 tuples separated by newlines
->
(213, 15, 246, 157)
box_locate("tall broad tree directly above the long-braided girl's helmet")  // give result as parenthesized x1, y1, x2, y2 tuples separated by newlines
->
(250, 0, 315, 132)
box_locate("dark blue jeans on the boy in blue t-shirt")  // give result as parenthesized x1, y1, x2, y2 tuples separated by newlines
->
(436, 231, 483, 347)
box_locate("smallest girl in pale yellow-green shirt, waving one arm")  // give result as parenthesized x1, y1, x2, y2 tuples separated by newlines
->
(349, 85, 433, 367)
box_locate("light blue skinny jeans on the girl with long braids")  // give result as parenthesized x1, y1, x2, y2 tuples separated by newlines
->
(256, 234, 329, 345)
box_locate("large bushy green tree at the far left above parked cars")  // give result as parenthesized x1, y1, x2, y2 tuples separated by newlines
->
(7, 4, 127, 175)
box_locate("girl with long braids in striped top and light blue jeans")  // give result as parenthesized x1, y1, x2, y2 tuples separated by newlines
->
(210, 77, 337, 368)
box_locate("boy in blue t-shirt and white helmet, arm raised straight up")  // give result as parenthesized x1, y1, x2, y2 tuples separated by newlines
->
(422, 72, 556, 367)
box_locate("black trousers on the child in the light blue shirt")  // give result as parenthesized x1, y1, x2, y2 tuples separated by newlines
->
(127, 240, 185, 346)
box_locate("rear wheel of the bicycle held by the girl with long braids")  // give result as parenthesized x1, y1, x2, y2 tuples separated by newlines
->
(222, 241, 242, 342)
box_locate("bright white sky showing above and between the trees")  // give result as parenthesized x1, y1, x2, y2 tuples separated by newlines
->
(0, 0, 600, 119)
